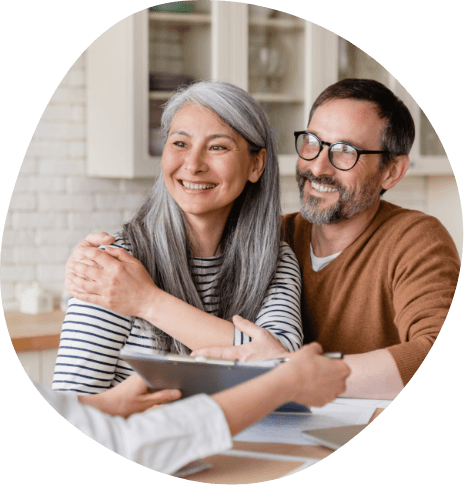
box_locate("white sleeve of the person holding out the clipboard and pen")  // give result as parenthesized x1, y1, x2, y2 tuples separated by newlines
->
(36, 384, 232, 474)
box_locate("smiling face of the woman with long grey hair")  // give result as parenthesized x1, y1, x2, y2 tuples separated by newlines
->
(162, 104, 266, 223)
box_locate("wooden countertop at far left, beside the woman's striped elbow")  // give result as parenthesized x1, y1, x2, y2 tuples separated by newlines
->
(5, 310, 65, 352)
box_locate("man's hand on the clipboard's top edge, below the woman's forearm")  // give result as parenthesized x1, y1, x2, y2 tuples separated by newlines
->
(191, 315, 288, 361)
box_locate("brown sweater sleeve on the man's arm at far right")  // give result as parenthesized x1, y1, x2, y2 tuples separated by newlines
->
(388, 214, 460, 384)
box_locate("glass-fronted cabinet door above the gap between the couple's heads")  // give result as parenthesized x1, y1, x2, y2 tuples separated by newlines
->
(243, 5, 310, 176)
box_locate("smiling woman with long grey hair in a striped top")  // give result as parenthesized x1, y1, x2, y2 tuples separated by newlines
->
(53, 82, 302, 393)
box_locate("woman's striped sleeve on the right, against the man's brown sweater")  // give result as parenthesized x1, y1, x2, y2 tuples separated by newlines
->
(234, 242, 303, 352)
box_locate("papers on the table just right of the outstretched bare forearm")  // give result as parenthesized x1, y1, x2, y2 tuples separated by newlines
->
(234, 403, 375, 445)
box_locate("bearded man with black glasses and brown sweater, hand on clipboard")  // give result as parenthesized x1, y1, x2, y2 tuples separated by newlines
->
(195, 79, 460, 399)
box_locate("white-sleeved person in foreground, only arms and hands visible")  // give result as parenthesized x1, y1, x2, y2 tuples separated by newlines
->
(37, 343, 349, 473)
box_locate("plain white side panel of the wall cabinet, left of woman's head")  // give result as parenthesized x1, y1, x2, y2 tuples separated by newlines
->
(86, 10, 157, 178)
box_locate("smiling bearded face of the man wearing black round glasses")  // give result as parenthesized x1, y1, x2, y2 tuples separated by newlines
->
(297, 99, 384, 224)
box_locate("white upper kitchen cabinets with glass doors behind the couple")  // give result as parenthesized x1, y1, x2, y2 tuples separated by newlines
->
(86, 0, 453, 178)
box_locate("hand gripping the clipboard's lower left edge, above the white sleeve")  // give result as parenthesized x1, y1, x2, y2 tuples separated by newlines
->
(78, 374, 181, 418)
